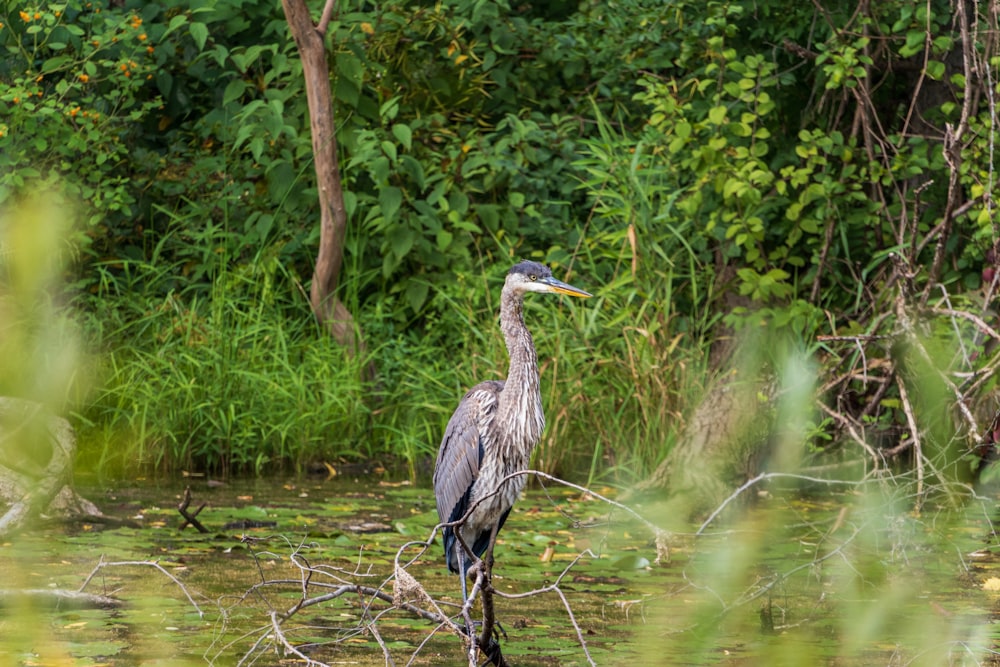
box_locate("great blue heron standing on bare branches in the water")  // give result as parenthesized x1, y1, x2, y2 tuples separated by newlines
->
(434, 261, 592, 602)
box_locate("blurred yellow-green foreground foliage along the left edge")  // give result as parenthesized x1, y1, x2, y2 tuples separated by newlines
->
(0, 192, 84, 665)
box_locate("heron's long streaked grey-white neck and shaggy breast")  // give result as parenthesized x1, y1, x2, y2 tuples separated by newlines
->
(497, 289, 545, 454)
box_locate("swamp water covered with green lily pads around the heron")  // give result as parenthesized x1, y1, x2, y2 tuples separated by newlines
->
(0, 478, 1000, 666)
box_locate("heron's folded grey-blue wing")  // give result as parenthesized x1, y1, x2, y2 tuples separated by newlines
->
(434, 380, 503, 522)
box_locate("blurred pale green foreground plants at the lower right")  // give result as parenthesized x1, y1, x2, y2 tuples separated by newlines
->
(641, 349, 995, 667)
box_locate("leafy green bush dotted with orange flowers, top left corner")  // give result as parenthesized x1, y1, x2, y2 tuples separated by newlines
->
(0, 2, 159, 240)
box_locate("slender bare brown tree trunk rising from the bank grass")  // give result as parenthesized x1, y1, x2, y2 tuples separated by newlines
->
(281, 0, 361, 352)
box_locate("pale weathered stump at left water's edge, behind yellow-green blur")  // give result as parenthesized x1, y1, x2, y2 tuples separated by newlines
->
(0, 397, 102, 537)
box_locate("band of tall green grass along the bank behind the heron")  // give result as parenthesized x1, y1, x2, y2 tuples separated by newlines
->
(78, 237, 699, 480)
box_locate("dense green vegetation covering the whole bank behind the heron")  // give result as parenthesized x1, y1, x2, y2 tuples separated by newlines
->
(0, 0, 1000, 479)
